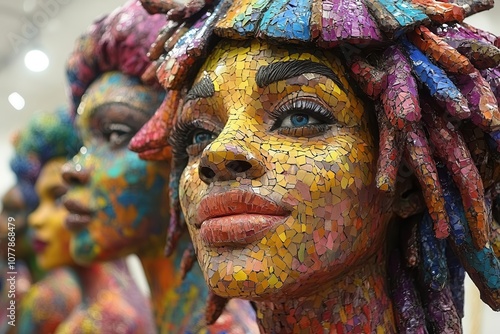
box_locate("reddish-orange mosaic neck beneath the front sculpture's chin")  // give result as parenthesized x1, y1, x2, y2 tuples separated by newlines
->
(257, 257, 396, 333)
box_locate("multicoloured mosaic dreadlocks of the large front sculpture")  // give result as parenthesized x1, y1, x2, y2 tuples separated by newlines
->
(131, 0, 500, 332)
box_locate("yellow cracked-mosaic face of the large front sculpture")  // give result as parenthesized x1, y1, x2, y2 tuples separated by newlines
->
(175, 40, 389, 299)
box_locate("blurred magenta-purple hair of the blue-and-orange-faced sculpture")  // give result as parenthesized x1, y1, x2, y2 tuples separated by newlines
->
(66, 0, 165, 113)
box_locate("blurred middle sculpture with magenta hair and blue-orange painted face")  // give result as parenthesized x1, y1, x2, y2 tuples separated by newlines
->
(63, 1, 256, 333)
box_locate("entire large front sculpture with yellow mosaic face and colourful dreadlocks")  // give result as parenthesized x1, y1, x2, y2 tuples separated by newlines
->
(130, 0, 500, 333)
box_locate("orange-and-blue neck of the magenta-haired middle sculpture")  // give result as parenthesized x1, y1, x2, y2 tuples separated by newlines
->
(139, 235, 208, 333)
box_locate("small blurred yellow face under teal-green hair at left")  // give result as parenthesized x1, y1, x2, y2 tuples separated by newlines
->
(28, 158, 74, 270)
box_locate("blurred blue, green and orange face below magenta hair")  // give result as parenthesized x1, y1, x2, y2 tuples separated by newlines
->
(64, 72, 169, 263)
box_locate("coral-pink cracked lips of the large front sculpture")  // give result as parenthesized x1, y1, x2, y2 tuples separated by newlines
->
(196, 190, 290, 246)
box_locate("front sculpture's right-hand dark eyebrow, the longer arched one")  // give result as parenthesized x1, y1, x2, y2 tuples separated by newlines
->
(255, 60, 346, 92)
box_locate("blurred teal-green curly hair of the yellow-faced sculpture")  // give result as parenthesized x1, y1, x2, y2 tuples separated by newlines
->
(10, 108, 81, 211)
